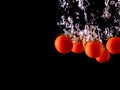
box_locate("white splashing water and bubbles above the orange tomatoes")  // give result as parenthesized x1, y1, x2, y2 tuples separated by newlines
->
(57, 0, 120, 42)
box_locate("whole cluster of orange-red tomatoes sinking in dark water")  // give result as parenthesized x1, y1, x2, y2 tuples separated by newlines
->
(54, 35, 120, 63)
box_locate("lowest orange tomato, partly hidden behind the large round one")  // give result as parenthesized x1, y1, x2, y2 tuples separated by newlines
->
(96, 50, 110, 63)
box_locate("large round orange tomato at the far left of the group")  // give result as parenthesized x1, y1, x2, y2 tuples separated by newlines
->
(54, 35, 73, 54)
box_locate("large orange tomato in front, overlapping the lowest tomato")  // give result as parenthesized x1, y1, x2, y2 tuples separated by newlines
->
(85, 41, 104, 58)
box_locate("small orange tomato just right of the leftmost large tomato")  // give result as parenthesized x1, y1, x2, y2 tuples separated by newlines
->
(72, 42, 84, 53)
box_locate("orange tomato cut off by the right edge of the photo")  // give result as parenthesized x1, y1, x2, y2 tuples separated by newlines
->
(106, 37, 120, 54)
